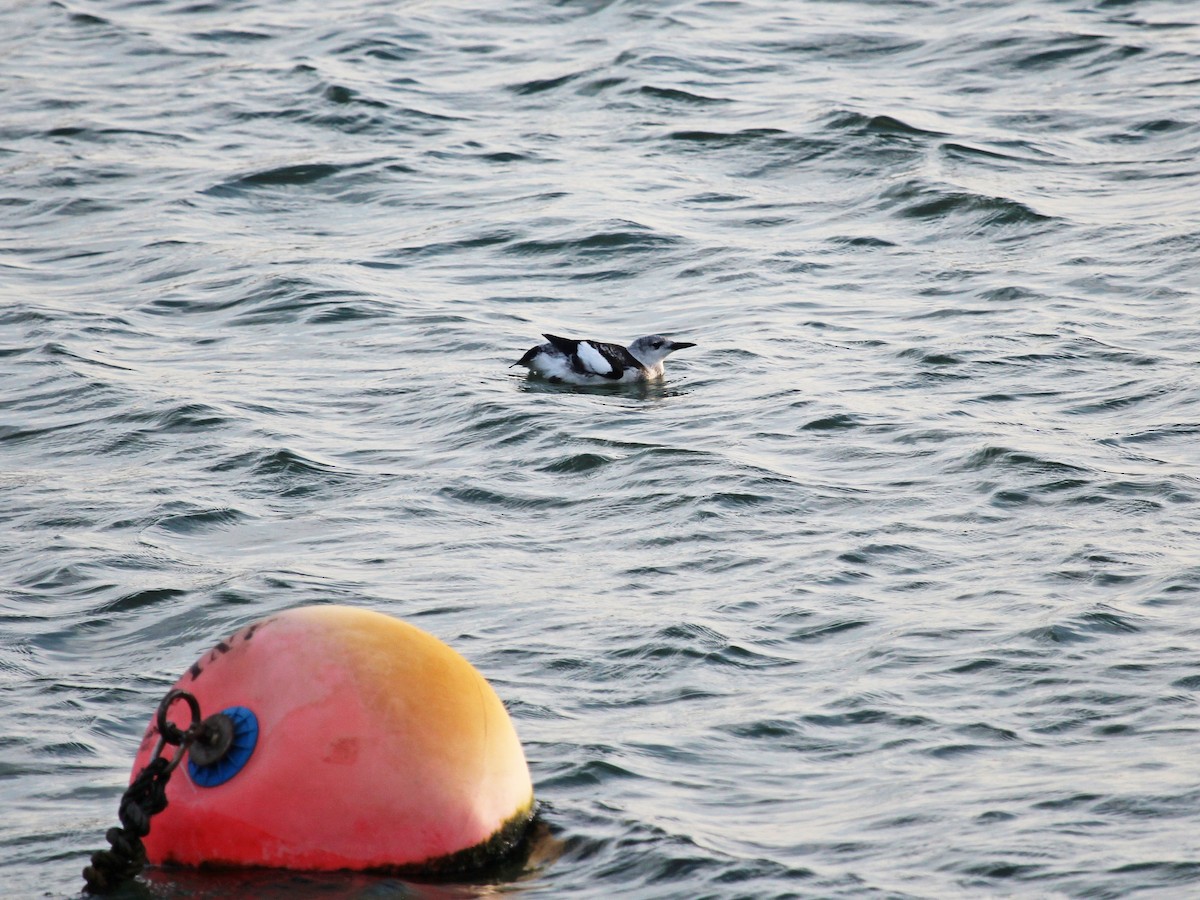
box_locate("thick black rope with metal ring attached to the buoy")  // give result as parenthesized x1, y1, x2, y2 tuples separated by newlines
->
(83, 690, 200, 894)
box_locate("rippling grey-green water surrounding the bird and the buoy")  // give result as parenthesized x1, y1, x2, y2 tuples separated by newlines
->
(0, 0, 1200, 898)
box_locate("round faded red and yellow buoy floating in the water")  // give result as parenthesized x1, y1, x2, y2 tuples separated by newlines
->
(133, 606, 533, 874)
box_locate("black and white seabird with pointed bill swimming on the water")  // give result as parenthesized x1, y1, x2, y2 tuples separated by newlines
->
(512, 335, 696, 384)
